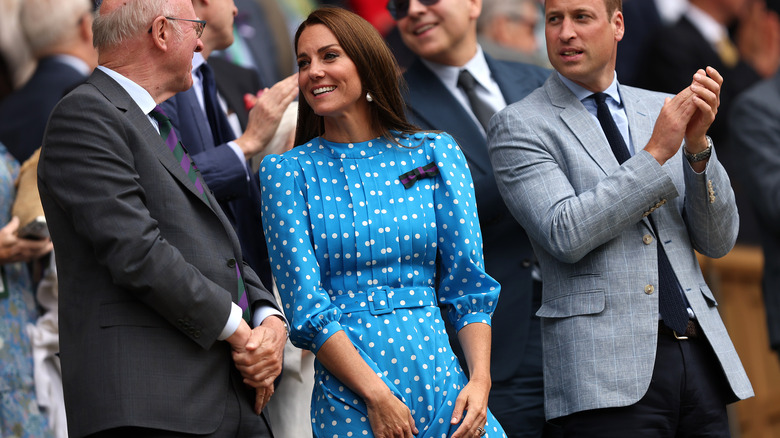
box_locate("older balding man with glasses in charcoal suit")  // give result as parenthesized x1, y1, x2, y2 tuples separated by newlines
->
(38, 0, 286, 437)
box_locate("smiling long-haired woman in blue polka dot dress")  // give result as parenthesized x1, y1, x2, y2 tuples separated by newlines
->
(260, 8, 505, 438)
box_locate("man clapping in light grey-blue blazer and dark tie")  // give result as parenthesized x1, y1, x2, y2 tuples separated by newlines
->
(488, 0, 753, 437)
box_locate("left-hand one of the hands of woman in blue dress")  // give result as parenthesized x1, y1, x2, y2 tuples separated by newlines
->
(364, 386, 418, 438)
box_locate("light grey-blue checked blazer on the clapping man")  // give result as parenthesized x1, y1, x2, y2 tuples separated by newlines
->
(488, 74, 753, 419)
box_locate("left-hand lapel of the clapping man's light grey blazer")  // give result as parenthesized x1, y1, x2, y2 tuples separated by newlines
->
(544, 74, 620, 175)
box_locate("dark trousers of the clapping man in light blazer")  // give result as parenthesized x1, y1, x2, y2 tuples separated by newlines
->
(558, 326, 732, 438)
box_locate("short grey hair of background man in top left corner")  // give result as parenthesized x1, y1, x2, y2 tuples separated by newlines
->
(19, 0, 92, 58)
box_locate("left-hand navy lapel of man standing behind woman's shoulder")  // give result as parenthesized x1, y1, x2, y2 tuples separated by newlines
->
(405, 59, 492, 173)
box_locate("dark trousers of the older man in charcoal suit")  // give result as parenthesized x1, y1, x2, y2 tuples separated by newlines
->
(87, 369, 273, 438)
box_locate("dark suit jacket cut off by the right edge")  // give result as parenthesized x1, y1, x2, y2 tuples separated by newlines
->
(729, 73, 780, 352)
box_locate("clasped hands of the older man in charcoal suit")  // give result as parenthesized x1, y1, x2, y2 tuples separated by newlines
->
(227, 316, 287, 414)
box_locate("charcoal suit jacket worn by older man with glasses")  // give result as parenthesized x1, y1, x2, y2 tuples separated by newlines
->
(38, 70, 275, 437)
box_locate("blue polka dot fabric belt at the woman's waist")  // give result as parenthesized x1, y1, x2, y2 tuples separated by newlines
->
(330, 286, 436, 315)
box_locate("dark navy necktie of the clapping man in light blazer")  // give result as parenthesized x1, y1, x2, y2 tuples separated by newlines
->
(593, 93, 688, 334)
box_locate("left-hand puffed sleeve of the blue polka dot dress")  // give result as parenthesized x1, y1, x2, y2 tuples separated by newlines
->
(260, 152, 342, 353)
